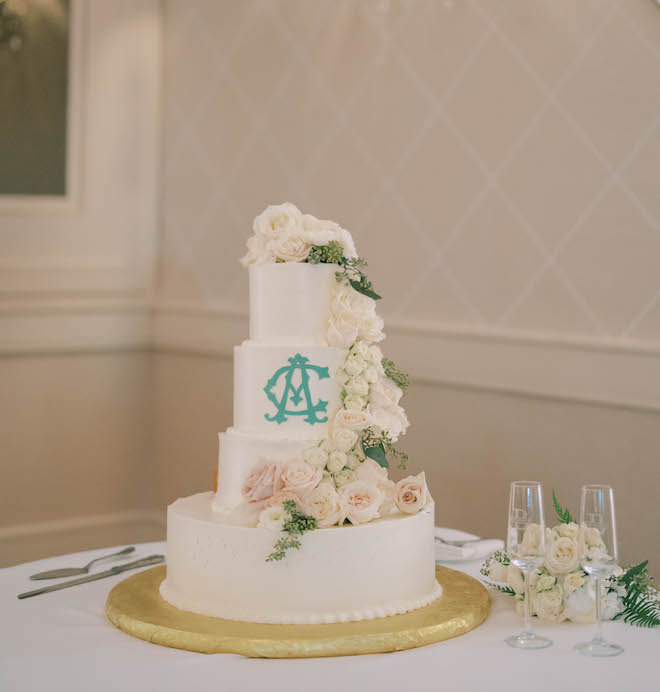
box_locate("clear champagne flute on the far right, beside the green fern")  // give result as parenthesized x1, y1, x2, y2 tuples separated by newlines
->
(575, 485, 623, 656)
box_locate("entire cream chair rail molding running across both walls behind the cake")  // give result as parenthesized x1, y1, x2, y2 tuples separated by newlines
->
(5, 298, 660, 411)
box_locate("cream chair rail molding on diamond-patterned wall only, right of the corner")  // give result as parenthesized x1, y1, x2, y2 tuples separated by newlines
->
(152, 303, 660, 411)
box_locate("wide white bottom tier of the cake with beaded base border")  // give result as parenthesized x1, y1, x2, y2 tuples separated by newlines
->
(160, 492, 442, 624)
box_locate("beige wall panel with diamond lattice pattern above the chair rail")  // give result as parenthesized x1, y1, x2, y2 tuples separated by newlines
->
(159, 0, 660, 343)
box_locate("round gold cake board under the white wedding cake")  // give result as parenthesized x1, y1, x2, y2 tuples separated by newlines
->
(105, 565, 490, 658)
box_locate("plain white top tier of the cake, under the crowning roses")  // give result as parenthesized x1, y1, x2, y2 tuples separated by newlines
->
(250, 262, 337, 346)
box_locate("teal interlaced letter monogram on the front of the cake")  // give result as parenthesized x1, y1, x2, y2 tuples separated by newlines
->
(264, 353, 330, 425)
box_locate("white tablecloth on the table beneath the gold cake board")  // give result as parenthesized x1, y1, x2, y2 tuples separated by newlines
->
(0, 543, 660, 692)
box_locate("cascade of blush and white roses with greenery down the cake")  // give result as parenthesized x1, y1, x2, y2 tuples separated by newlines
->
(241, 203, 432, 561)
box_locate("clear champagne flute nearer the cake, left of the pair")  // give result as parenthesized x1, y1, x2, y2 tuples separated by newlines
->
(504, 481, 552, 649)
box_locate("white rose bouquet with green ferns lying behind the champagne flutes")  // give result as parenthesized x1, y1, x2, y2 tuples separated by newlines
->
(481, 491, 660, 627)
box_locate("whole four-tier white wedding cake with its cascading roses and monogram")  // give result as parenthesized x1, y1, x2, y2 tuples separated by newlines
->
(161, 203, 442, 624)
